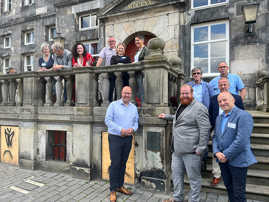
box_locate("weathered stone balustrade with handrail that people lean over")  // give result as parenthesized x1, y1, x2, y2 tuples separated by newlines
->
(0, 59, 183, 106)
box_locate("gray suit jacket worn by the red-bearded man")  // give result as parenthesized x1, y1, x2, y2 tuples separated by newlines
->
(165, 100, 211, 155)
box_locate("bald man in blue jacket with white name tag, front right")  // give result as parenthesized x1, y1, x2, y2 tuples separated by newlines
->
(213, 92, 257, 202)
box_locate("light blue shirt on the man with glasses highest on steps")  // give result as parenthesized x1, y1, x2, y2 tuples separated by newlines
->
(209, 73, 245, 97)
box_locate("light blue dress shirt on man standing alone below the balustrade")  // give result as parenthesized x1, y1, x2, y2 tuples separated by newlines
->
(105, 99, 139, 135)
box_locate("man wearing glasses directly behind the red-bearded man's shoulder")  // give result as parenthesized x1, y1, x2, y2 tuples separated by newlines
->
(187, 67, 210, 108)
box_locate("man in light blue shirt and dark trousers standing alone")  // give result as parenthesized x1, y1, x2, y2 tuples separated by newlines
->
(105, 86, 139, 202)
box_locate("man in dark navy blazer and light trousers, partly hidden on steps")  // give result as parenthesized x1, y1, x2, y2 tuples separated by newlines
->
(208, 77, 244, 186)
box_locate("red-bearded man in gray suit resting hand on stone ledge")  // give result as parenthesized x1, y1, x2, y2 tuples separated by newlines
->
(159, 84, 210, 202)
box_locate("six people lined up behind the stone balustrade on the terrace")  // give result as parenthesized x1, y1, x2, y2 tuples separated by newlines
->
(39, 35, 148, 105)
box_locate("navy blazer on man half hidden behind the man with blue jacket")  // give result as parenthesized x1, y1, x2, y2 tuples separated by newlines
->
(208, 94, 245, 131)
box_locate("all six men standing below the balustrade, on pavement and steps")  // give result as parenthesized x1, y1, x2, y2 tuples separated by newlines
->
(102, 62, 257, 202)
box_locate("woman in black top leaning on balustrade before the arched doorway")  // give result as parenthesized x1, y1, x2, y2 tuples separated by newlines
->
(110, 43, 131, 87)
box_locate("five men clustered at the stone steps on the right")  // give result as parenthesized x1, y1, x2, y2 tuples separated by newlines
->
(159, 62, 257, 202)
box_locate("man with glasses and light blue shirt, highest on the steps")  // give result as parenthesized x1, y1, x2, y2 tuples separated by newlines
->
(209, 62, 246, 100)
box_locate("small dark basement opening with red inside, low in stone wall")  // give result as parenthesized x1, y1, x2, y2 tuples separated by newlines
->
(46, 130, 66, 161)
